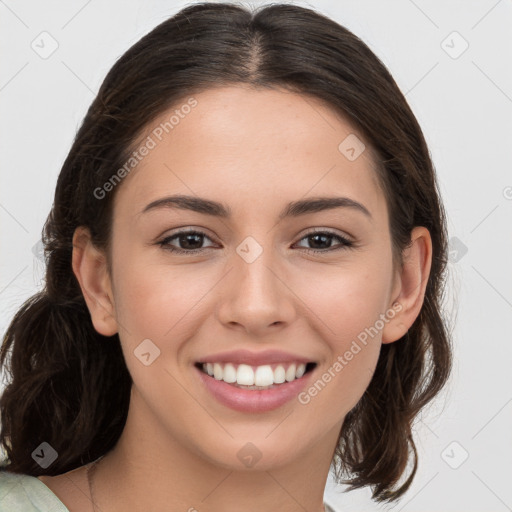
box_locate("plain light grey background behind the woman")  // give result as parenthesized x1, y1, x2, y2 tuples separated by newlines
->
(0, 0, 512, 512)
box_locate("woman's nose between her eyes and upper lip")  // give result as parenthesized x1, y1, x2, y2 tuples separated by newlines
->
(217, 250, 297, 337)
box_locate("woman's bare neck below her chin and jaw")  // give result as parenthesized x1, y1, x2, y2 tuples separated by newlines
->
(89, 390, 341, 512)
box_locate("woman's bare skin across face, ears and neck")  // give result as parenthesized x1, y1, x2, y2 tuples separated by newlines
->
(41, 86, 432, 512)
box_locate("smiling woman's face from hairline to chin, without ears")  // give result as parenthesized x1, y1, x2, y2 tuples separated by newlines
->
(92, 86, 397, 468)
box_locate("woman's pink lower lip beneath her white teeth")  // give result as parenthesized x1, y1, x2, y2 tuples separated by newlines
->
(194, 367, 315, 412)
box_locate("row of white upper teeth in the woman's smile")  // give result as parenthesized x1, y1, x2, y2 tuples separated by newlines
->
(202, 363, 306, 389)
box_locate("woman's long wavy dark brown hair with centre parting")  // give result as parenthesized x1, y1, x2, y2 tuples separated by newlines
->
(0, 2, 451, 501)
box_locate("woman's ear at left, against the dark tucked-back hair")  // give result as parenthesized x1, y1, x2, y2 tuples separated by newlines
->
(72, 226, 118, 336)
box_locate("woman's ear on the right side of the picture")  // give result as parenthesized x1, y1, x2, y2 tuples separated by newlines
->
(382, 226, 432, 343)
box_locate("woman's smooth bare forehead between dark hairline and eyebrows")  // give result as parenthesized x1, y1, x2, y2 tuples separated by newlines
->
(115, 86, 383, 222)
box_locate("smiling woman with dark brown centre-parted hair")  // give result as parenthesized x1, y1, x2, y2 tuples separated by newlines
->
(0, 3, 451, 512)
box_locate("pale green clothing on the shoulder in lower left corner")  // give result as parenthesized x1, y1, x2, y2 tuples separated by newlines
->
(0, 470, 69, 512)
